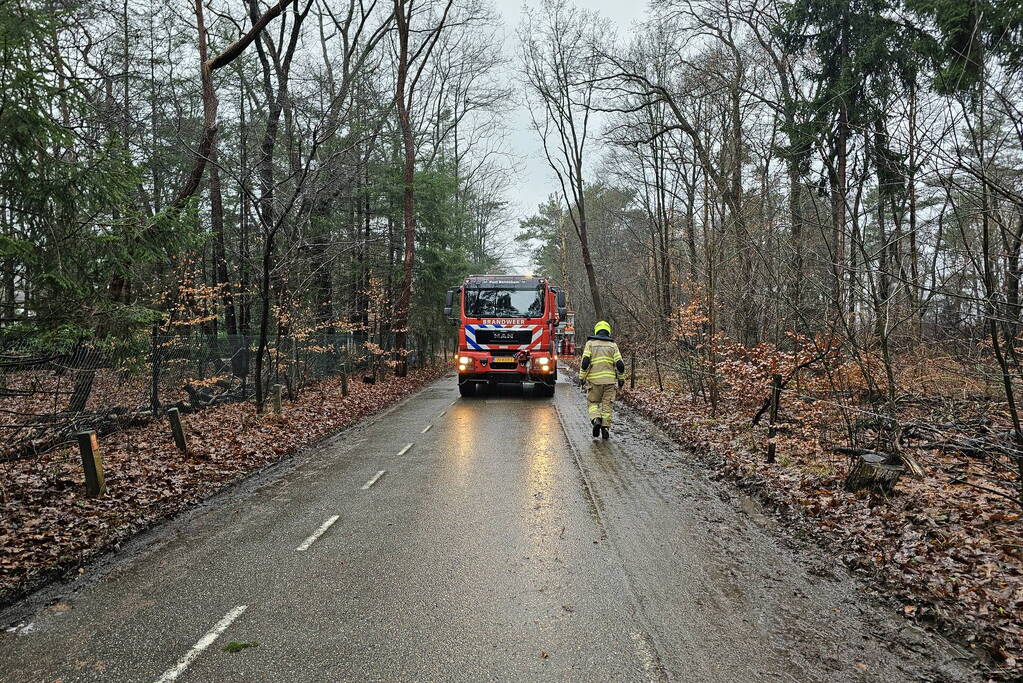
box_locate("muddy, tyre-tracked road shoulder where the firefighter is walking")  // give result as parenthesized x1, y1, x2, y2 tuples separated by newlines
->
(558, 376, 979, 680)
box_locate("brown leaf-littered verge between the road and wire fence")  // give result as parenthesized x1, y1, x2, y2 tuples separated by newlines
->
(0, 364, 449, 607)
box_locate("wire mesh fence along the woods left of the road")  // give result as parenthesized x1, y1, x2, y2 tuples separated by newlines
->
(0, 332, 422, 461)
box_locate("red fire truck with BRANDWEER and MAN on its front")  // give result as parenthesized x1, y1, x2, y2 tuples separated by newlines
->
(444, 275, 566, 397)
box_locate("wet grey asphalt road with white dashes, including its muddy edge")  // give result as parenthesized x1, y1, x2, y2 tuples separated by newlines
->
(0, 377, 974, 682)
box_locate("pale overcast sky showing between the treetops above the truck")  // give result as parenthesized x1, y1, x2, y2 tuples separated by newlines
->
(493, 0, 647, 270)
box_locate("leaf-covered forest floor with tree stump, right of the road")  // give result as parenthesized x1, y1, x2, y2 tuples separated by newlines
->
(605, 359, 1023, 680)
